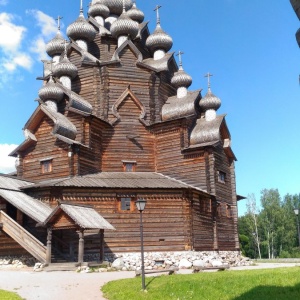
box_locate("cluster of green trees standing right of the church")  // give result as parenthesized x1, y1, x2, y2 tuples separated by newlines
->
(238, 189, 300, 258)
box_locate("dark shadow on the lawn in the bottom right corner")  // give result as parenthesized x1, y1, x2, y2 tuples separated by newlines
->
(233, 284, 300, 300)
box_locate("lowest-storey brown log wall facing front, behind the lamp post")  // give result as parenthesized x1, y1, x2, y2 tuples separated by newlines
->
(57, 189, 192, 253)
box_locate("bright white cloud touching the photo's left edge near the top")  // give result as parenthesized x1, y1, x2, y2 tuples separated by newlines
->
(0, 12, 26, 53)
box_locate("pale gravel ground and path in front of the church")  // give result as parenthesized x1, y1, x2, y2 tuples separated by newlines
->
(0, 263, 300, 300)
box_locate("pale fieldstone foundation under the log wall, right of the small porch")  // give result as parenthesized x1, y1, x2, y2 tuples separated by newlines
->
(106, 251, 252, 271)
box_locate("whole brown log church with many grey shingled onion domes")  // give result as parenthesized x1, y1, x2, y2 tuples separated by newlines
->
(0, 0, 239, 263)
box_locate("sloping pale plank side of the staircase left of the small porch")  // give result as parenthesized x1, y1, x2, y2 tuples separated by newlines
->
(0, 210, 47, 263)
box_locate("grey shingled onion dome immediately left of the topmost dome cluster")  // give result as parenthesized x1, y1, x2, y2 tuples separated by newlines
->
(67, 6, 96, 41)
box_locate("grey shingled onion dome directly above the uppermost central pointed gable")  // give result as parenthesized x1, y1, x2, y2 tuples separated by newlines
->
(110, 10, 139, 39)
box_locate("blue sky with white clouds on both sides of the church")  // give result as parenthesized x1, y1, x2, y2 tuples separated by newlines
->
(0, 0, 300, 214)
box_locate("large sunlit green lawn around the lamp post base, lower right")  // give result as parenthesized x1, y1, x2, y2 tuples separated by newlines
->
(102, 267, 300, 300)
